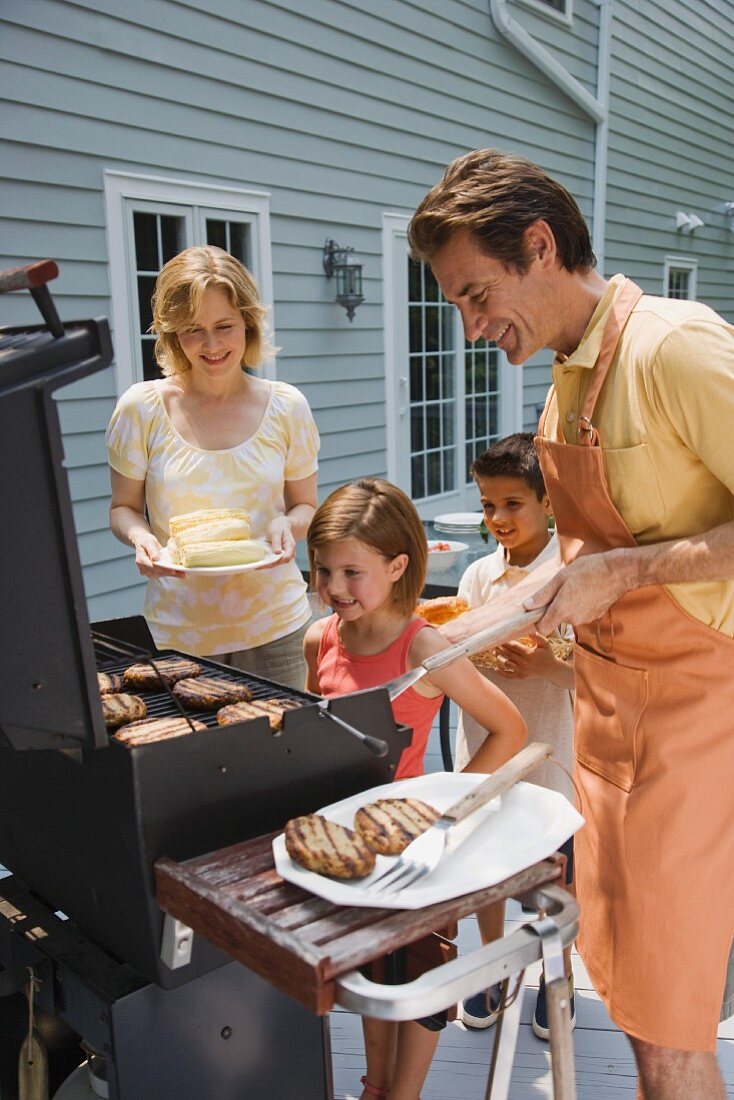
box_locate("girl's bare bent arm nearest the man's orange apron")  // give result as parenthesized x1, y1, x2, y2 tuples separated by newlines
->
(409, 627, 527, 772)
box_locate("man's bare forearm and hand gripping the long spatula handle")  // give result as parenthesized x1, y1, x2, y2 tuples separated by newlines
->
(524, 521, 734, 634)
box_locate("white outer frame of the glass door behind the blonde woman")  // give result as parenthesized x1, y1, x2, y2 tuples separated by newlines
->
(105, 169, 275, 394)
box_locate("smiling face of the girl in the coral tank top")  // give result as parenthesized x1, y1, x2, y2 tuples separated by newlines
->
(314, 538, 408, 623)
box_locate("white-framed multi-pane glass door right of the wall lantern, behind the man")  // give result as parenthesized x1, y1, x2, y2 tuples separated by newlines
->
(383, 213, 523, 517)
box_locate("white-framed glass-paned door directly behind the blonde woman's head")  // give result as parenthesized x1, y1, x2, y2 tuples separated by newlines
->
(105, 172, 274, 393)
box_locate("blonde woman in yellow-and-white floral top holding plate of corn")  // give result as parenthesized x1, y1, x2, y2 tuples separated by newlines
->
(107, 245, 319, 689)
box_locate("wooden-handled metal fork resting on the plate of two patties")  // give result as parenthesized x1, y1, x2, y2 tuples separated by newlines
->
(366, 741, 552, 894)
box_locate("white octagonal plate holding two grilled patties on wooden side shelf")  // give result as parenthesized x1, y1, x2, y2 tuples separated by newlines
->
(273, 772, 583, 909)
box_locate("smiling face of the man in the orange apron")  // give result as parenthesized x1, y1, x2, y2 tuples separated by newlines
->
(431, 223, 558, 364)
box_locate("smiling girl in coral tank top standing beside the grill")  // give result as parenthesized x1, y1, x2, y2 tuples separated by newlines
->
(304, 477, 527, 1100)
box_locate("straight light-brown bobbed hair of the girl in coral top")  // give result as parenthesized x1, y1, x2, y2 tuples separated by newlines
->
(307, 477, 428, 615)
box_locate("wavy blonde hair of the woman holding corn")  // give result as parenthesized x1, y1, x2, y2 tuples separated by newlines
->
(149, 244, 275, 375)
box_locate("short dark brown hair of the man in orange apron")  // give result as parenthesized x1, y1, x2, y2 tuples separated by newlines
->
(408, 149, 596, 275)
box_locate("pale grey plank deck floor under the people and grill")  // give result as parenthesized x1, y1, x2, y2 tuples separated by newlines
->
(331, 704, 734, 1100)
